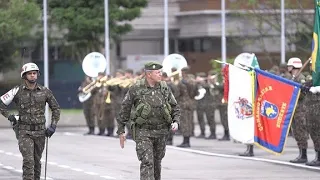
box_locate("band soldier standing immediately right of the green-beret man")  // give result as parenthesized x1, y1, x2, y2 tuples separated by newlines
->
(177, 67, 198, 147)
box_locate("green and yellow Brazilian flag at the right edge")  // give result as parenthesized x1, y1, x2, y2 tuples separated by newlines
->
(311, 0, 320, 86)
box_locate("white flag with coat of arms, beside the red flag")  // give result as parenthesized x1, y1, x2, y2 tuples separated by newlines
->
(228, 65, 254, 144)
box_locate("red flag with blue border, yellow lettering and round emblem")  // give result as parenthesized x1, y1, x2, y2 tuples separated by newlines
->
(254, 69, 301, 154)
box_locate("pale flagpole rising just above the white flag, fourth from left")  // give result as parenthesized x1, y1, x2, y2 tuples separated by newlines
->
(221, 0, 227, 63)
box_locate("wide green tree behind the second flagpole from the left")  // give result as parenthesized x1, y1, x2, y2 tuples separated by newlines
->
(40, 0, 147, 59)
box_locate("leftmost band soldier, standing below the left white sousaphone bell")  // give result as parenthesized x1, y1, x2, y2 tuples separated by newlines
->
(78, 76, 95, 135)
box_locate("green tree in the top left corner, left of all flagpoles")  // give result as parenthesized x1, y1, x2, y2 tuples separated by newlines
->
(0, 0, 41, 72)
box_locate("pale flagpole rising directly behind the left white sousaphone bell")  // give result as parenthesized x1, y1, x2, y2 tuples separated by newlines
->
(104, 0, 111, 75)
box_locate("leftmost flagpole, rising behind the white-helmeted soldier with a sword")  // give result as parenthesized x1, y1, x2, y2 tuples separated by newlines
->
(43, 0, 49, 126)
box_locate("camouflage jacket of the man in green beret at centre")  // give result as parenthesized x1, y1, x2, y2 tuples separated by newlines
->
(117, 79, 181, 134)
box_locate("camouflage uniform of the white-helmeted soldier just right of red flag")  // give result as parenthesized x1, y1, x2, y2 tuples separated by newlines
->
(290, 74, 309, 163)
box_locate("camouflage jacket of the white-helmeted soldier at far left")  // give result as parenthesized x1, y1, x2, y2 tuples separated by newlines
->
(0, 84, 60, 125)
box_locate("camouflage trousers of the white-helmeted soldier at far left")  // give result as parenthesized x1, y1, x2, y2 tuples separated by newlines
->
(18, 130, 45, 180)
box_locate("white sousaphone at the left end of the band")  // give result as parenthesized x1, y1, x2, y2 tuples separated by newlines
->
(78, 52, 107, 102)
